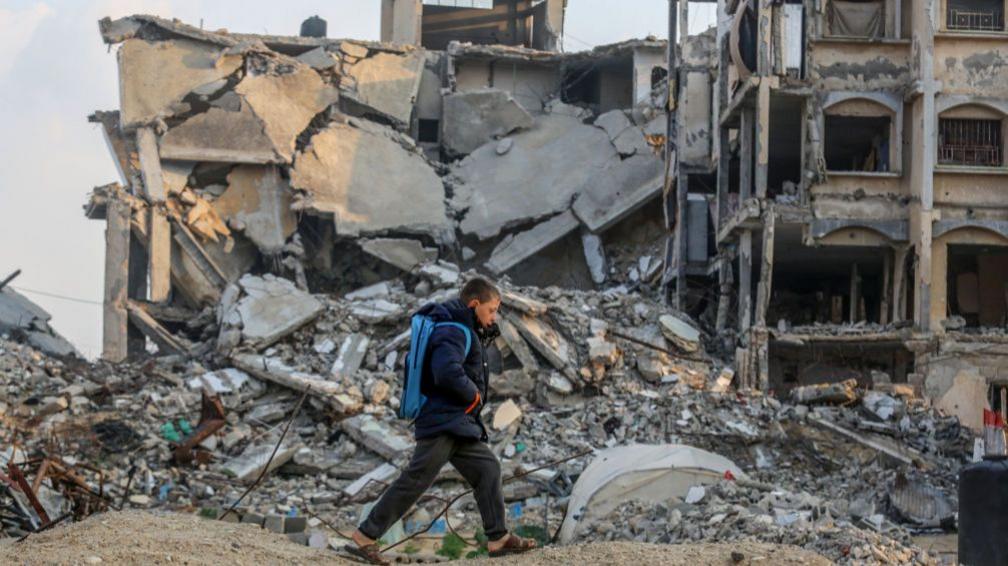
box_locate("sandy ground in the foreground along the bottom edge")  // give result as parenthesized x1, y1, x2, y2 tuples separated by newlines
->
(0, 511, 830, 566)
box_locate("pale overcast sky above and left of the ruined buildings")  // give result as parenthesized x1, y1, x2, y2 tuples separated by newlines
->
(0, 0, 714, 358)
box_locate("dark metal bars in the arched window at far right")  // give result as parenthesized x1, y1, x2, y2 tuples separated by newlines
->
(938, 118, 1003, 167)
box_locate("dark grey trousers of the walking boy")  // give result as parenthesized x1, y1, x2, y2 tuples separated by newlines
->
(360, 434, 507, 541)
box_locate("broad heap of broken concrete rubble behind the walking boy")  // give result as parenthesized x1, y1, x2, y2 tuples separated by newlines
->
(0, 262, 971, 561)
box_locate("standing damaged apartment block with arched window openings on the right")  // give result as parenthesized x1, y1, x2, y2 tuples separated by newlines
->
(664, 0, 1008, 418)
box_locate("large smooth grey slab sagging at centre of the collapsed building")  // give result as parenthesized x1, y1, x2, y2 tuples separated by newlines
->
(450, 114, 619, 240)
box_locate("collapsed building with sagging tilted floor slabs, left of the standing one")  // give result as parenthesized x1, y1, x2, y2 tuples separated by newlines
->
(86, 0, 681, 360)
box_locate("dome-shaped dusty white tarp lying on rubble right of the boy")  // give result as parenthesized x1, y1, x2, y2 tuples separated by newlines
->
(559, 444, 746, 544)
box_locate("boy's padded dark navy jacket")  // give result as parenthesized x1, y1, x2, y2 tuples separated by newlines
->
(414, 299, 489, 441)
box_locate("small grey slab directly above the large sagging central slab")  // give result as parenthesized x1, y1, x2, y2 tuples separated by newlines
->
(442, 90, 534, 155)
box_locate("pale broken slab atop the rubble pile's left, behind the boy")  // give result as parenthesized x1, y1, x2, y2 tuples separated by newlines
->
(236, 273, 326, 348)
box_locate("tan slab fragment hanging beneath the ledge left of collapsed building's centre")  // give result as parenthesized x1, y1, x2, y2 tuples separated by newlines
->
(213, 165, 297, 250)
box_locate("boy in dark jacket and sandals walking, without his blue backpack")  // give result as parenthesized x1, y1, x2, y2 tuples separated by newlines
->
(347, 277, 535, 564)
